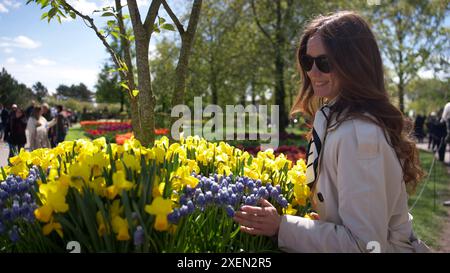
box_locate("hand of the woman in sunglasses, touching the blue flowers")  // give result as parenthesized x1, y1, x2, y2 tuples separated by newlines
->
(233, 199, 281, 236)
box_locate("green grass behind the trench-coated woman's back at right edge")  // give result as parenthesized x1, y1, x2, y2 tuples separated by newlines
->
(409, 151, 450, 250)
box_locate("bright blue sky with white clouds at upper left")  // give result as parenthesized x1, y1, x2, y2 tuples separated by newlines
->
(0, 0, 180, 92)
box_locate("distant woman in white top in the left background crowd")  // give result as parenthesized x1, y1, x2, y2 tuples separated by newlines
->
(26, 106, 56, 151)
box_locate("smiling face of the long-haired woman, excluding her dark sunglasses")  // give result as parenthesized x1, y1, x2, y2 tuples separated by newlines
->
(306, 35, 338, 100)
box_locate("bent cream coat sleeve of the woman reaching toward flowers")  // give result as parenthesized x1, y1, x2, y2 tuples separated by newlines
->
(278, 120, 388, 252)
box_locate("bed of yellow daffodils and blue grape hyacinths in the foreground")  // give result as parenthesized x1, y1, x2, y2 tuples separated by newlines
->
(0, 137, 309, 252)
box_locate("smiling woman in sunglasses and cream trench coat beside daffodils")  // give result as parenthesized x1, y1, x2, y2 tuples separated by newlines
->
(234, 12, 428, 252)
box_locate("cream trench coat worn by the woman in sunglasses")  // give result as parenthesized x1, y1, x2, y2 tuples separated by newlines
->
(278, 114, 428, 252)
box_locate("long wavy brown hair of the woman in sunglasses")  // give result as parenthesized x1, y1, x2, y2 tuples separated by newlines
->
(291, 11, 424, 193)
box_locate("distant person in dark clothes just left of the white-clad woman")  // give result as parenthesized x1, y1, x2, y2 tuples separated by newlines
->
(9, 108, 27, 157)
